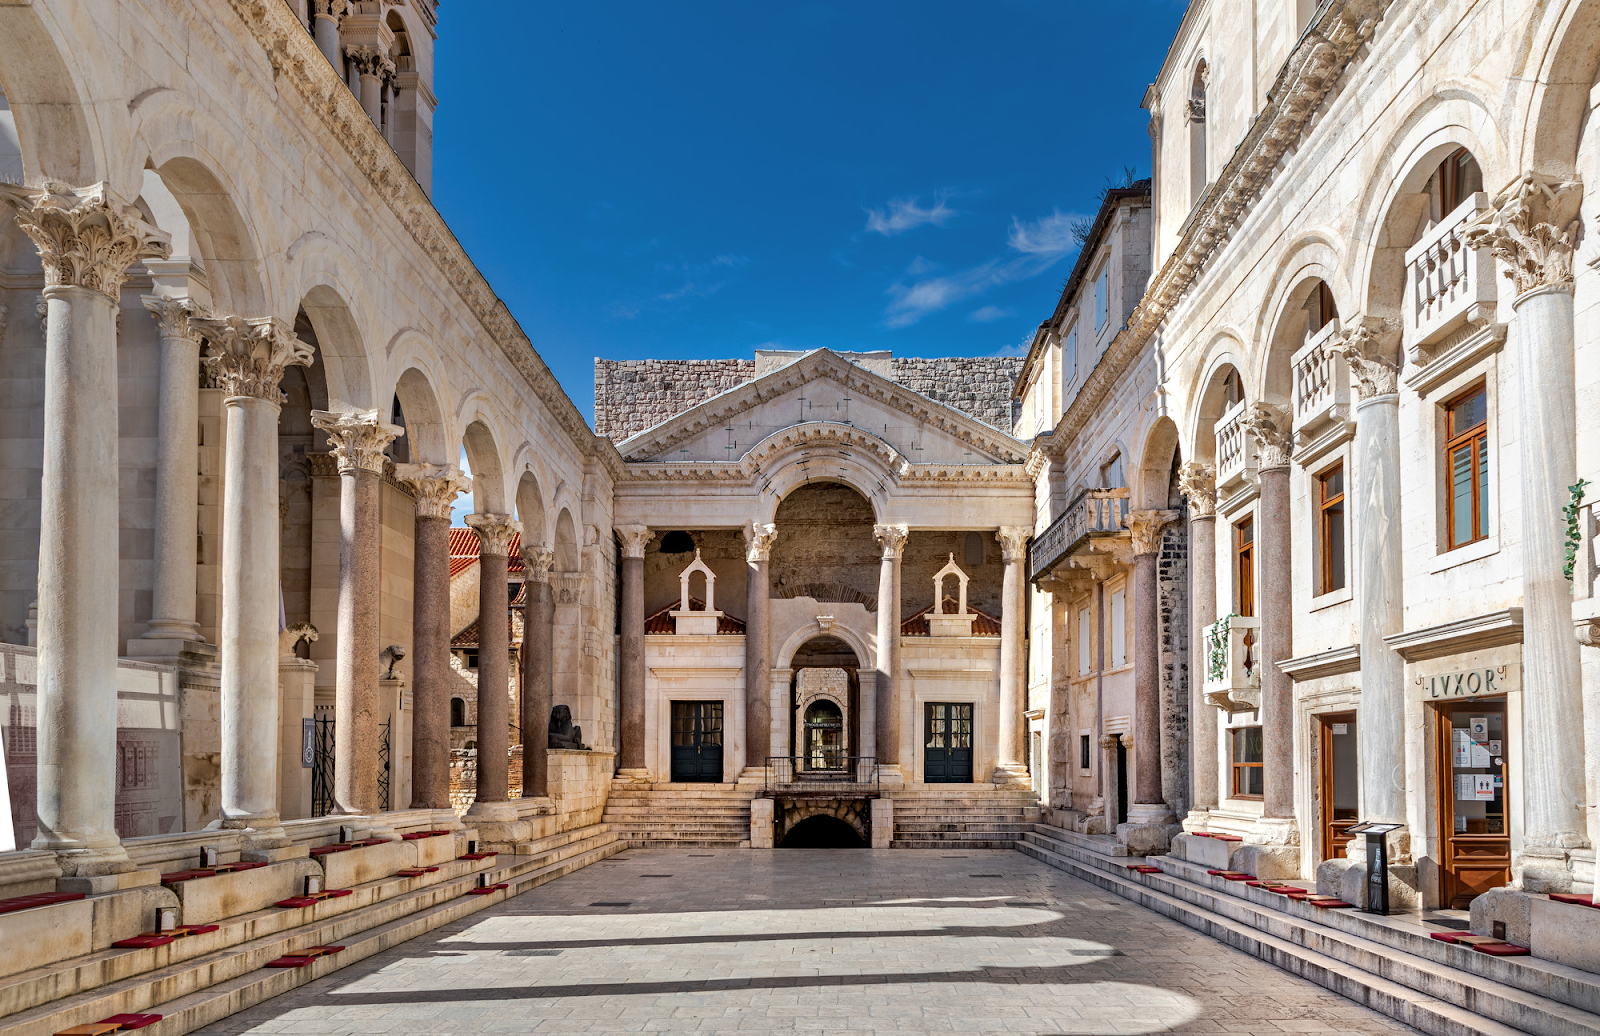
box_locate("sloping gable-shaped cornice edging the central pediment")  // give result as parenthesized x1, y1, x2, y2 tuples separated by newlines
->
(618, 349, 1027, 464)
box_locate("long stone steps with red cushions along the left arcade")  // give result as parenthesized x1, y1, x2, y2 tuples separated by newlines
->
(0, 823, 627, 1036)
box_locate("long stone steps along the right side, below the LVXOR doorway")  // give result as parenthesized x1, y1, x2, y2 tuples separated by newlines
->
(1018, 825, 1600, 1036)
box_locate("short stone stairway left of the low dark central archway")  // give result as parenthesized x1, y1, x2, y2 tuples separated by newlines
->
(602, 780, 760, 849)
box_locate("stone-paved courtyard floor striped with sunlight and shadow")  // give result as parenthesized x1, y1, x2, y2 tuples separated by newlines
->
(200, 849, 1414, 1036)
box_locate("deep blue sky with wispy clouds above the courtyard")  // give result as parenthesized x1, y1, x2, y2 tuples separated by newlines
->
(434, 0, 1184, 416)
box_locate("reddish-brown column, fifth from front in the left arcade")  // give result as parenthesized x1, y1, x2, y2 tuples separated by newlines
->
(467, 515, 522, 822)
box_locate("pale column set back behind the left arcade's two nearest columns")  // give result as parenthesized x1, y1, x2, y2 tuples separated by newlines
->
(141, 296, 205, 648)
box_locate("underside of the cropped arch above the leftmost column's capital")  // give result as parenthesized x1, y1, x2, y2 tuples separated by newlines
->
(0, 3, 107, 187)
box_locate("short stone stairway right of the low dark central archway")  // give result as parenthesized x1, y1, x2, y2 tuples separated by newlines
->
(886, 785, 1040, 849)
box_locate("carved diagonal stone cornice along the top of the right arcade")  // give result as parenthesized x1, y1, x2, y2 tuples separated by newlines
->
(1050, 0, 1394, 457)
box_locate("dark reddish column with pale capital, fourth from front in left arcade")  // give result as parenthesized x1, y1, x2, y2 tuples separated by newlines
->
(395, 464, 472, 809)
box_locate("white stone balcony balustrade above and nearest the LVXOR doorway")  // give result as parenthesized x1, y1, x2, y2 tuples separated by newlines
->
(1405, 192, 1496, 353)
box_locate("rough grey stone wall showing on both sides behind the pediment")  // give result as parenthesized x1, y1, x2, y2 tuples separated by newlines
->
(595, 357, 1022, 443)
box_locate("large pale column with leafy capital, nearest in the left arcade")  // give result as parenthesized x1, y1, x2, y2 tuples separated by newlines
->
(0, 184, 170, 891)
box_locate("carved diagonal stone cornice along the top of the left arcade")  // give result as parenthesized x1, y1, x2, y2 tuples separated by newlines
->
(229, 0, 611, 457)
